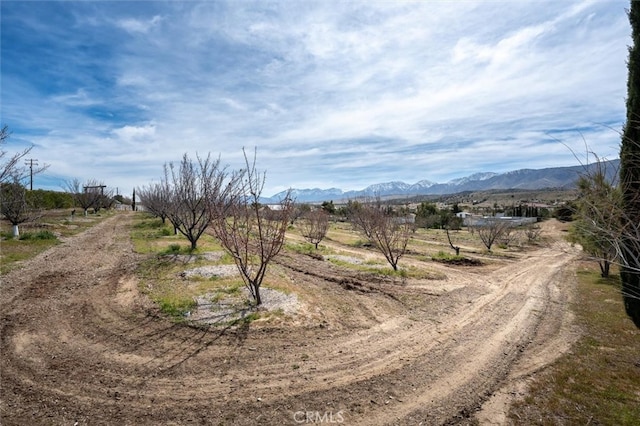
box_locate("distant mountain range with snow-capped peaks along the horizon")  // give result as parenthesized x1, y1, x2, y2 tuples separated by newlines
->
(263, 160, 620, 203)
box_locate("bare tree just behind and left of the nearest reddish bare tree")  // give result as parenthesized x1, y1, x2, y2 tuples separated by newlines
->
(168, 154, 226, 250)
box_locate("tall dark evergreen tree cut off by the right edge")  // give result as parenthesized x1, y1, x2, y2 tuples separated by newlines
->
(620, 0, 640, 328)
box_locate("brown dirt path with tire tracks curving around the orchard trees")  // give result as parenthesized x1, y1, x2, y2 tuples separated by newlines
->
(0, 214, 576, 425)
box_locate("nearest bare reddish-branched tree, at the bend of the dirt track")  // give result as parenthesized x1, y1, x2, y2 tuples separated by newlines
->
(211, 150, 294, 306)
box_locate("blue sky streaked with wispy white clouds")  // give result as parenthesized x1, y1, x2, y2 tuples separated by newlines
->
(0, 0, 631, 196)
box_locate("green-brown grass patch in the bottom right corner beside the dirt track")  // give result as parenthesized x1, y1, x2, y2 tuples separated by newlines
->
(509, 267, 640, 425)
